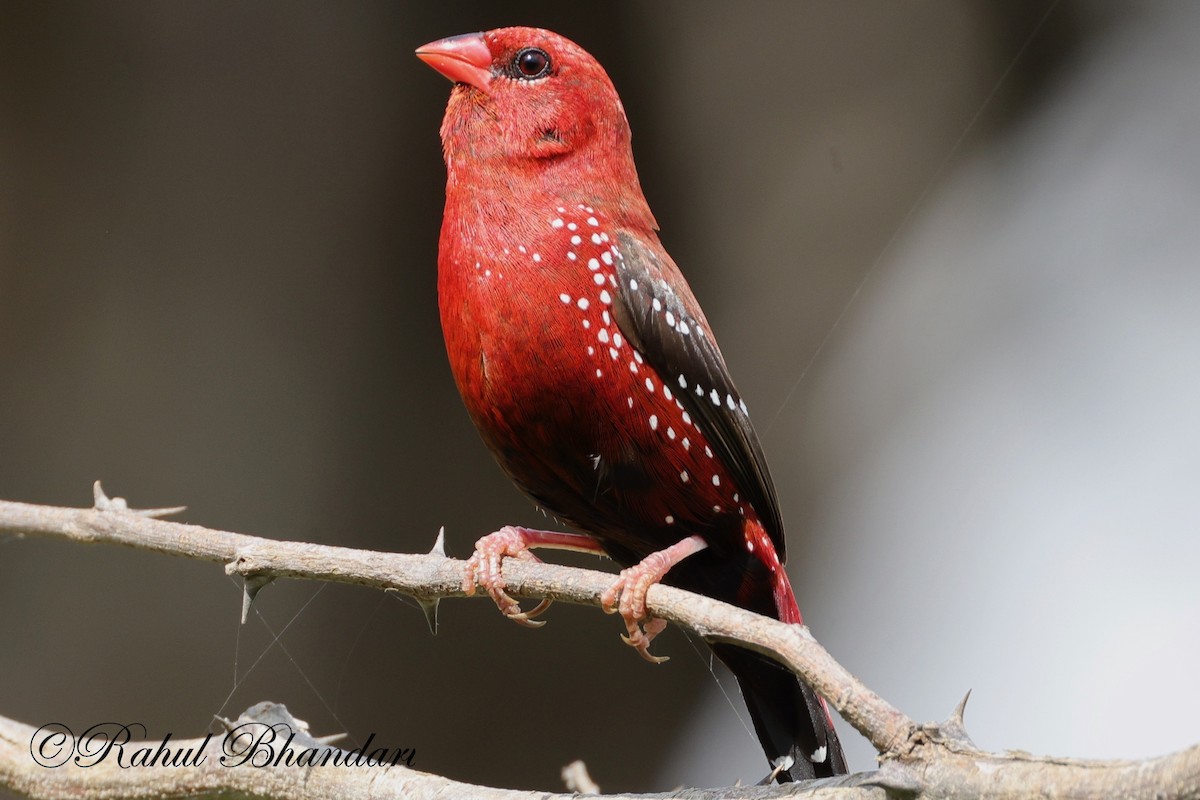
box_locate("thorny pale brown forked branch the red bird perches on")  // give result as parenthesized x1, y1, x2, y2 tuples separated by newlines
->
(0, 483, 1200, 798)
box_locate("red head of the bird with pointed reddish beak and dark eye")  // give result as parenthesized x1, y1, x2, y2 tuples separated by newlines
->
(416, 28, 653, 224)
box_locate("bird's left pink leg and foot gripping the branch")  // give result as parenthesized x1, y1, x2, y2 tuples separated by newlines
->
(462, 525, 605, 627)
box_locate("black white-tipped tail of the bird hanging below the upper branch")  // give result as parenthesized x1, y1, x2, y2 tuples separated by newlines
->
(712, 644, 848, 783)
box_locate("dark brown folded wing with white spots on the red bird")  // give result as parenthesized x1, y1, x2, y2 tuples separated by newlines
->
(613, 231, 786, 561)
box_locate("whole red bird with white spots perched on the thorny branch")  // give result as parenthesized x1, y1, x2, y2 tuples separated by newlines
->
(416, 28, 846, 781)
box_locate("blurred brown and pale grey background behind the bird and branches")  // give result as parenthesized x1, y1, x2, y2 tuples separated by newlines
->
(0, 0, 1200, 790)
